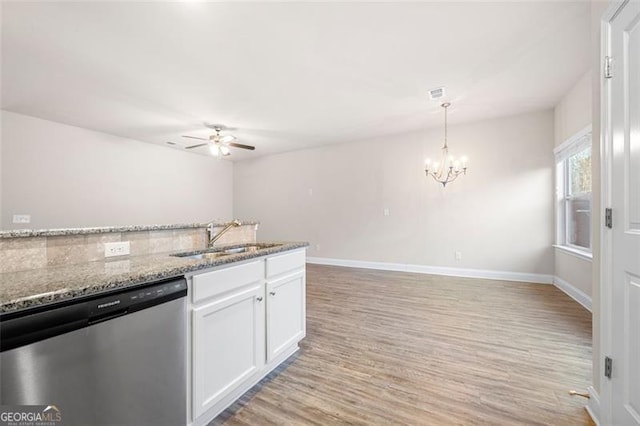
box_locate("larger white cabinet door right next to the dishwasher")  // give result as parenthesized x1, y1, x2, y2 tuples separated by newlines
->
(192, 284, 265, 418)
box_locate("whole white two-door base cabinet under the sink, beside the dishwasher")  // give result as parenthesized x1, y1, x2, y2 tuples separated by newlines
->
(190, 249, 306, 426)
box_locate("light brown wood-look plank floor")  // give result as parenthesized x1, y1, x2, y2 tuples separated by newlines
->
(214, 265, 592, 426)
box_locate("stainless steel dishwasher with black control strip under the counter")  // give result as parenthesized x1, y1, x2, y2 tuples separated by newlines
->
(0, 278, 187, 426)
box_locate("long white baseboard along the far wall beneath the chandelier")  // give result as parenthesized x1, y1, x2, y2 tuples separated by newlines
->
(307, 257, 554, 284)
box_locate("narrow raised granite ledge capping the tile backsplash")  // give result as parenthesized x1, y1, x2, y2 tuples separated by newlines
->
(0, 220, 259, 238)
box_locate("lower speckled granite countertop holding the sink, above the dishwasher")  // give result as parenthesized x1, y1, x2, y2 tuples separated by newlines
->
(0, 242, 309, 314)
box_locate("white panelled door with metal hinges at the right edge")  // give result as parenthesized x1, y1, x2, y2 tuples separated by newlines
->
(608, 0, 640, 426)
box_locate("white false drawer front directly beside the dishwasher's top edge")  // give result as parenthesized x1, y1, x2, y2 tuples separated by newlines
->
(192, 260, 264, 303)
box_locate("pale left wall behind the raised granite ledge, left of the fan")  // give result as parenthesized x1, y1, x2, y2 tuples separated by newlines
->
(0, 111, 233, 229)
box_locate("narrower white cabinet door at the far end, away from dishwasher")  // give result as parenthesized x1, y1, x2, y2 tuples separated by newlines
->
(267, 270, 306, 362)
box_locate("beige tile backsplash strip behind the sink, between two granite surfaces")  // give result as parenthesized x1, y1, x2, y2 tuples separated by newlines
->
(0, 224, 257, 273)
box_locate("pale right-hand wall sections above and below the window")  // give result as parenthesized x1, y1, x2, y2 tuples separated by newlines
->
(554, 71, 596, 297)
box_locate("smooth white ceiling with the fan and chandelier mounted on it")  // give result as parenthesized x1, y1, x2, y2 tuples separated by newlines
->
(2, 1, 590, 160)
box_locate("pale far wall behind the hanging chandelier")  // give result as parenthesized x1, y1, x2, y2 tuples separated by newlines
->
(234, 110, 554, 274)
